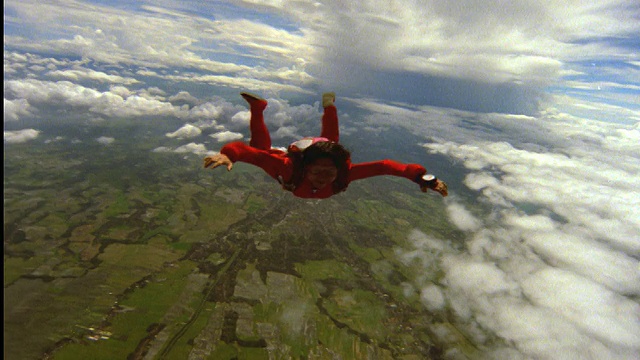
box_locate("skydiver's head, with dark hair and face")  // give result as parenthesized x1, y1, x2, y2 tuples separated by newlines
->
(303, 141, 351, 190)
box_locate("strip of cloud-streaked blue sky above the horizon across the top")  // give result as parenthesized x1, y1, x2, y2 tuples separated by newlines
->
(5, 0, 640, 114)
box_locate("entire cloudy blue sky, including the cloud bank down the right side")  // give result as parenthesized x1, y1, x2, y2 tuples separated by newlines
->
(4, 0, 640, 359)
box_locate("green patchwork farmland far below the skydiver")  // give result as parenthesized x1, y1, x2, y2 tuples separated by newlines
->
(4, 126, 473, 359)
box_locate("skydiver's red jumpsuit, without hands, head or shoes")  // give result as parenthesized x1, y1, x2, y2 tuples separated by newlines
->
(220, 100, 427, 199)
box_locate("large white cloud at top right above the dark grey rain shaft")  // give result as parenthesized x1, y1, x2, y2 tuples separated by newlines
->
(240, 1, 638, 88)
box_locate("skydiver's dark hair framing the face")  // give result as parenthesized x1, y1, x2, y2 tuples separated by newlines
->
(285, 141, 351, 194)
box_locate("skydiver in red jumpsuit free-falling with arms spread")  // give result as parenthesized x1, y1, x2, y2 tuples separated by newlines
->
(204, 92, 448, 199)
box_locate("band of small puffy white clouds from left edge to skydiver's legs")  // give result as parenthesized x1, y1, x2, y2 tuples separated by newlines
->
(4, 71, 321, 150)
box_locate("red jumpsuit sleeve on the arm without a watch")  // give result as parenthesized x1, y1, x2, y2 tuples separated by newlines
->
(220, 141, 292, 179)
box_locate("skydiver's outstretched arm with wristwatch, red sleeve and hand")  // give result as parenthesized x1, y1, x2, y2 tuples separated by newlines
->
(349, 160, 449, 196)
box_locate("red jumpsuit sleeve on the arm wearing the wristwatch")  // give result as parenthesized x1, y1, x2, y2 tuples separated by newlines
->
(349, 160, 427, 183)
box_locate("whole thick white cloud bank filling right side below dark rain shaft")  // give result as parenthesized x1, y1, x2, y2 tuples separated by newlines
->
(378, 97, 640, 359)
